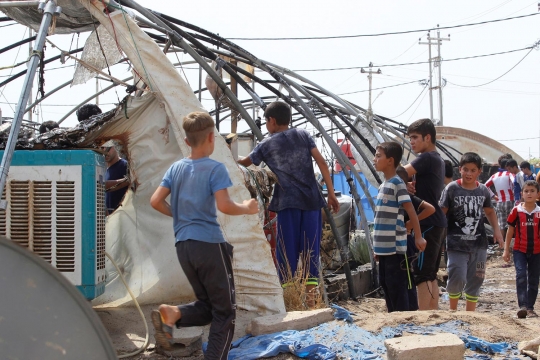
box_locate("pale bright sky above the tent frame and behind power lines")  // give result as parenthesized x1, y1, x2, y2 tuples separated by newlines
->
(0, 0, 540, 158)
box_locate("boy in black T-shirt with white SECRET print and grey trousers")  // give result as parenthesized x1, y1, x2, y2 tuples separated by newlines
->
(439, 152, 503, 311)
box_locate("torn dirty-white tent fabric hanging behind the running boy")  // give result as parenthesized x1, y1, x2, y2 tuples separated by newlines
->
(80, 0, 285, 314)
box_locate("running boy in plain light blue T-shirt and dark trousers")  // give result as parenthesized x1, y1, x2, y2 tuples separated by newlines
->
(150, 112, 258, 359)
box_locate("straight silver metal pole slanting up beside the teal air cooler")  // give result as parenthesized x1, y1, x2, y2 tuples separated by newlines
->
(0, 0, 62, 210)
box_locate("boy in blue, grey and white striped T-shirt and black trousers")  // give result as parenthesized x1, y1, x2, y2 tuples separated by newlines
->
(373, 142, 426, 312)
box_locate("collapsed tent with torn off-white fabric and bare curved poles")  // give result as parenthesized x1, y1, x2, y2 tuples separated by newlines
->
(0, 0, 524, 313)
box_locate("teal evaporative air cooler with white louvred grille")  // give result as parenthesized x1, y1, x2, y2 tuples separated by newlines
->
(0, 150, 105, 300)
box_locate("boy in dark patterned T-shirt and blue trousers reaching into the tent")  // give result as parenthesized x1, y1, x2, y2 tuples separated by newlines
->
(238, 101, 339, 307)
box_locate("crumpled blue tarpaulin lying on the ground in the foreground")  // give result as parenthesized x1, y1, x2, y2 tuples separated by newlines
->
(224, 306, 518, 360)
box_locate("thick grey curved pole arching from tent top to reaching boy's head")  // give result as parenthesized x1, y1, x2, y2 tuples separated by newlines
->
(118, 0, 263, 141)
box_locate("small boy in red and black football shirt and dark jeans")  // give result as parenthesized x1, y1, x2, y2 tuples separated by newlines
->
(503, 180, 540, 319)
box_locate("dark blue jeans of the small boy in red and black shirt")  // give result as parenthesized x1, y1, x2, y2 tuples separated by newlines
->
(514, 250, 540, 310)
